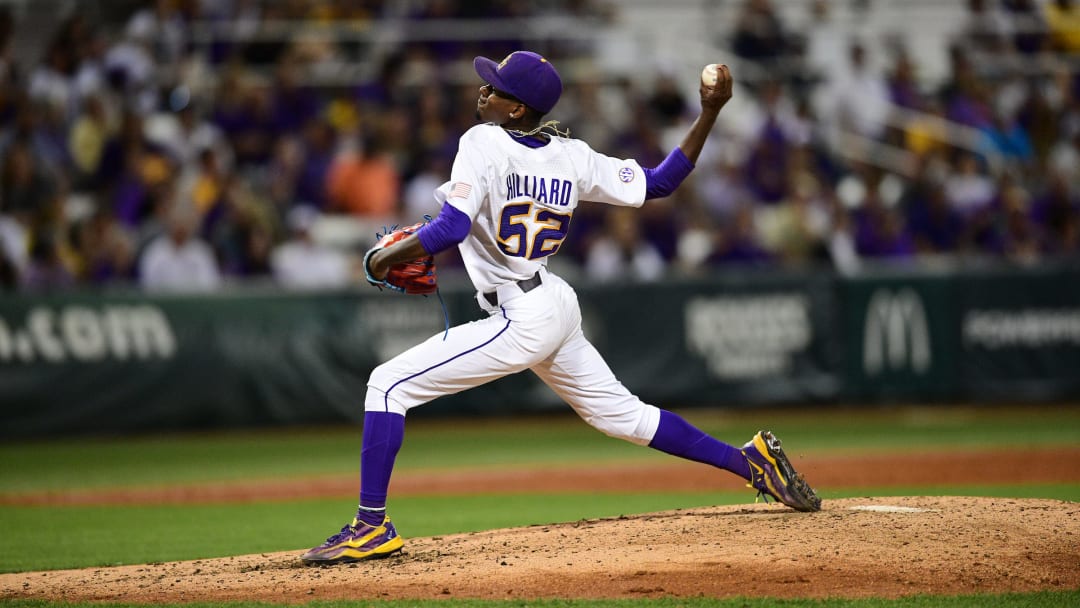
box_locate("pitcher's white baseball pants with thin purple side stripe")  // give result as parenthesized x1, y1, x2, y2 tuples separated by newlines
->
(364, 269, 660, 445)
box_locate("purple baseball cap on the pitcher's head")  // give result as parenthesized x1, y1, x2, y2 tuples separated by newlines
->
(473, 51, 563, 114)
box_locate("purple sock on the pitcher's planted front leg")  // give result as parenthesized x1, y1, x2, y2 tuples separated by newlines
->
(356, 411, 405, 526)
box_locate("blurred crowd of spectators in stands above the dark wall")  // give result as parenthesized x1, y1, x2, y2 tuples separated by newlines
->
(0, 0, 1080, 292)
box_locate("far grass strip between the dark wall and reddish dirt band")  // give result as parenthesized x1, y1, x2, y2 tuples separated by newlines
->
(0, 406, 1080, 494)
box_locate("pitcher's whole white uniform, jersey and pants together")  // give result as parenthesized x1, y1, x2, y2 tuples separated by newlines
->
(364, 124, 660, 445)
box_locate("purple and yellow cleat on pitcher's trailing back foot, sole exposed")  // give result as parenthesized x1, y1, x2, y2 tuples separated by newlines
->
(742, 431, 821, 511)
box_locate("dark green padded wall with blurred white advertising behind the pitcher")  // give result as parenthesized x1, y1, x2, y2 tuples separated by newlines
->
(0, 268, 1080, 437)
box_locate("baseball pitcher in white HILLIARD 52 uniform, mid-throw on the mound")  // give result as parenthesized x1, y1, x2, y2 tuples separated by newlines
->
(301, 51, 821, 564)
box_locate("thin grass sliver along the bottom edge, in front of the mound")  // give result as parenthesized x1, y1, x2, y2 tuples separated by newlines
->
(0, 591, 1080, 608)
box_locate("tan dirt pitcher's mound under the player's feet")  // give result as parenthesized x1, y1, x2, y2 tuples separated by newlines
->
(0, 497, 1080, 603)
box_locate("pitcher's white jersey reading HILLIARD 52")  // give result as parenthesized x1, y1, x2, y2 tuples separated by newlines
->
(435, 124, 645, 292)
